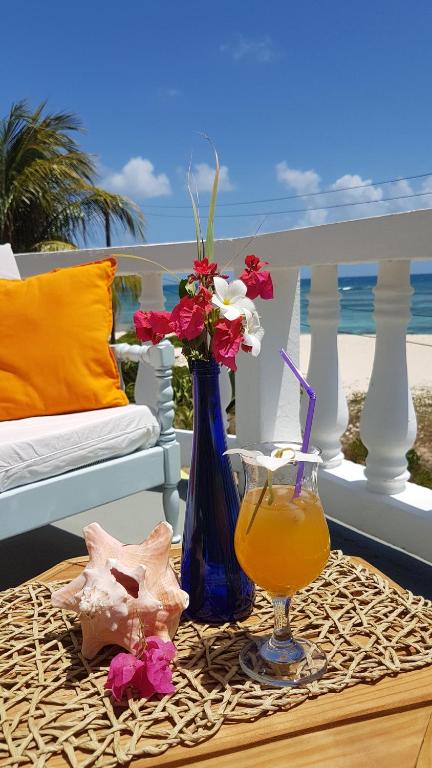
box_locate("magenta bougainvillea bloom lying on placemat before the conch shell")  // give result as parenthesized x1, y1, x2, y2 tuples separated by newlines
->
(105, 635, 175, 701)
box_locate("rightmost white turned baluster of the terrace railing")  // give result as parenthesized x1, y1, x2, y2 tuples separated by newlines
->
(360, 261, 417, 494)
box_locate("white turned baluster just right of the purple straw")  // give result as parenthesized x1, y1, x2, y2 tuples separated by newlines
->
(301, 265, 348, 467)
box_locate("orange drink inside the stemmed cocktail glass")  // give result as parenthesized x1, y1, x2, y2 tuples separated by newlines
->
(235, 485, 330, 596)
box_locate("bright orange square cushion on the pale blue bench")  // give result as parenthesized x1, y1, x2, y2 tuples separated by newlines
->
(0, 259, 128, 421)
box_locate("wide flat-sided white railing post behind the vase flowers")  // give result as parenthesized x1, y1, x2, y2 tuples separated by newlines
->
(236, 268, 300, 445)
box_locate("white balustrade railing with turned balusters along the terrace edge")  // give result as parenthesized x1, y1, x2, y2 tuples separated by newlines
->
(17, 211, 432, 561)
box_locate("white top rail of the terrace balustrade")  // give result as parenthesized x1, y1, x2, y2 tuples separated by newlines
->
(16, 210, 432, 277)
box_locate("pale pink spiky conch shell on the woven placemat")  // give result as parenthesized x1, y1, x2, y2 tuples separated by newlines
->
(51, 523, 189, 659)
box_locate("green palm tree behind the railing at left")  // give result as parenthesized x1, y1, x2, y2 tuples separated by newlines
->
(0, 101, 144, 337)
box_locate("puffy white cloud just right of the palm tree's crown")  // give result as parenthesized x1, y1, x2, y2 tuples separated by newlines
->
(102, 157, 171, 199)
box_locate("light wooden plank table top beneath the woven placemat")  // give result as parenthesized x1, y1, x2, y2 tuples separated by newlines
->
(38, 549, 432, 768)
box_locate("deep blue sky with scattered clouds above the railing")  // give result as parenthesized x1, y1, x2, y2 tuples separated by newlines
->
(0, 0, 432, 272)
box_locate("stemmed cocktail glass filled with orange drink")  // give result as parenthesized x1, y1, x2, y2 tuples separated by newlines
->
(234, 443, 330, 687)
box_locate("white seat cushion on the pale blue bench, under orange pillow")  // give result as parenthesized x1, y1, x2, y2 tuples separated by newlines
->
(0, 405, 160, 492)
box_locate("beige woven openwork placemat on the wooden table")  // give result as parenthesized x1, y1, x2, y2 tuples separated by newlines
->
(0, 552, 432, 768)
